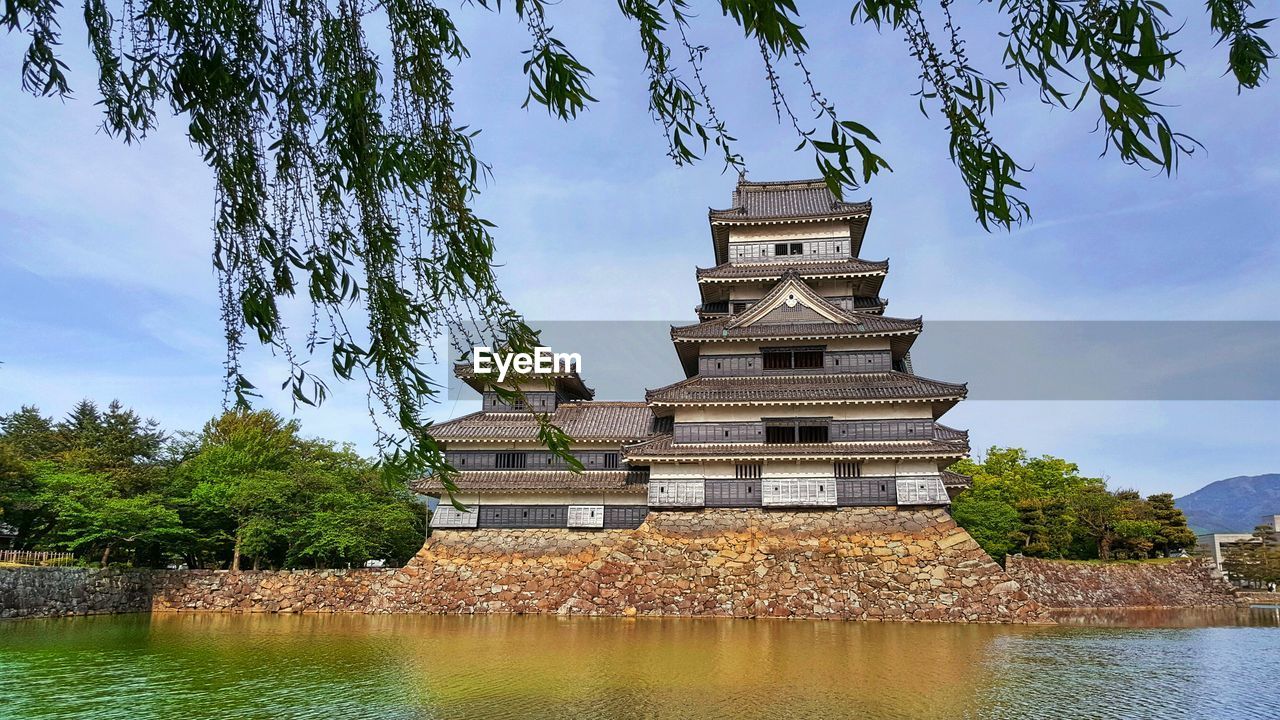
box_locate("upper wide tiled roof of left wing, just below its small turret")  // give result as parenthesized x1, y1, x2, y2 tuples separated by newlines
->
(429, 400, 655, 442)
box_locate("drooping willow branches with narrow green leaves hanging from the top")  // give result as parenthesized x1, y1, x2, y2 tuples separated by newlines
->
(0, 0, 1274, 491)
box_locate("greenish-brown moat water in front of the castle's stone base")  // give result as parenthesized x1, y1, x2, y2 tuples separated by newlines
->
(0, 609, 1280, 720)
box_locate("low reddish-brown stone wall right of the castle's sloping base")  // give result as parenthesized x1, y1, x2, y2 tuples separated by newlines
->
(1005, 555, 1235, 609)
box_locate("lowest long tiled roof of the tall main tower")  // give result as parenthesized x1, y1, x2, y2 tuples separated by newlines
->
(622, 436, 969, 461)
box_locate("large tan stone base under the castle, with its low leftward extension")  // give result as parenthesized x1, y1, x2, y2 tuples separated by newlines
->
(154, 507, 1046, 623)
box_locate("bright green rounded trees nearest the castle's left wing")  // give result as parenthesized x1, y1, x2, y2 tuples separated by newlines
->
(170, 410, 425, 570)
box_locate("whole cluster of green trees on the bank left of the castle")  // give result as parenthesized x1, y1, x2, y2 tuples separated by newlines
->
(0, 401, 426, 569)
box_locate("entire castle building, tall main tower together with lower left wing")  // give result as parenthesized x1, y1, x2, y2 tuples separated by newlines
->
(424, 179, 969, 528)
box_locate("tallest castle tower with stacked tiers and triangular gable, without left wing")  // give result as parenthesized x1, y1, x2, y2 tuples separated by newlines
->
(626, 181, 969, 507)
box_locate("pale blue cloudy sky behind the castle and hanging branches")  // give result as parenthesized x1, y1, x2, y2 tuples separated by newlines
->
(0, 0, 1280, 495)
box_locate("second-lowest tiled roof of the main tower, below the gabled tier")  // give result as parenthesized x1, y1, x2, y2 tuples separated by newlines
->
(645, 373, 968, 405)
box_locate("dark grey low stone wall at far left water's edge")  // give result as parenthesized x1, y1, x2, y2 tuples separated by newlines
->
(0, 568, 151, 619)
